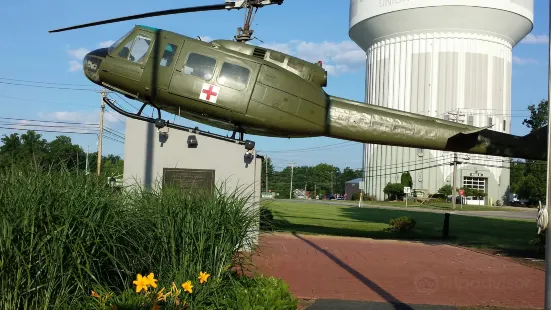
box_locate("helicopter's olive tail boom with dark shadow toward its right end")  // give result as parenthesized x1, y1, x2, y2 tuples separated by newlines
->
(326, 96, 547, 160)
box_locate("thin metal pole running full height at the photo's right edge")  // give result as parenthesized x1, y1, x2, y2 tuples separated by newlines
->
(545, 2, 551, 310)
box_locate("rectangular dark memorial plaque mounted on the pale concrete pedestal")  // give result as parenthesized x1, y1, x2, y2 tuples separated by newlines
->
(163, 168, 215, 193)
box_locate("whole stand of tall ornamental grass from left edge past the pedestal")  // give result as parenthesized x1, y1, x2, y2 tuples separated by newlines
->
(0, 170, 266, 309)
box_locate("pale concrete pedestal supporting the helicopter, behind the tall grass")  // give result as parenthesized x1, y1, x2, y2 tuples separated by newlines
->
(123, 118, 262, 247)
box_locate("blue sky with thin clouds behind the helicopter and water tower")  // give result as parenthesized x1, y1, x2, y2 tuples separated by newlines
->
(0, 0, 549, 170)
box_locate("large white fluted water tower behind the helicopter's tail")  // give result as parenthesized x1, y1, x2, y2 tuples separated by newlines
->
(349, 0, 534, 204)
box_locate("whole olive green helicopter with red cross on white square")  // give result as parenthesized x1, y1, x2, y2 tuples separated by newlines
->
(50, 0, 547, 160)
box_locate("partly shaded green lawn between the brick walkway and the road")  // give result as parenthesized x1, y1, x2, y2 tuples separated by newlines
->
(265, 200, 537, 257)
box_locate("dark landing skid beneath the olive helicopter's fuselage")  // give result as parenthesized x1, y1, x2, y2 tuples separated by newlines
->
(103, 97, 252, 145)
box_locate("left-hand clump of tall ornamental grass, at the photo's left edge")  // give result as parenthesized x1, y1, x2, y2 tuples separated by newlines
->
(0, 168, 150, 309)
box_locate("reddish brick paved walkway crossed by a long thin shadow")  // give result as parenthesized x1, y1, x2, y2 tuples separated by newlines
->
(254, 234, 545, 308)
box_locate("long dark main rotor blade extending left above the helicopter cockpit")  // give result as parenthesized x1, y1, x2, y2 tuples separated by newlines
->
(48, 2, 236, 33)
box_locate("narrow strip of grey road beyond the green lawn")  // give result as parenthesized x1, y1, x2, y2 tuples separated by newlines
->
(278, 199, 538, 223)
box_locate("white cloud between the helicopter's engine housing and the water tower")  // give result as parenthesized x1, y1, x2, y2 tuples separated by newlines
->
(262, 40, 365, 76)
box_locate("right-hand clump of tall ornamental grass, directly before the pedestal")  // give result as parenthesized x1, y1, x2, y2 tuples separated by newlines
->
(129, 179, 260, 281)
